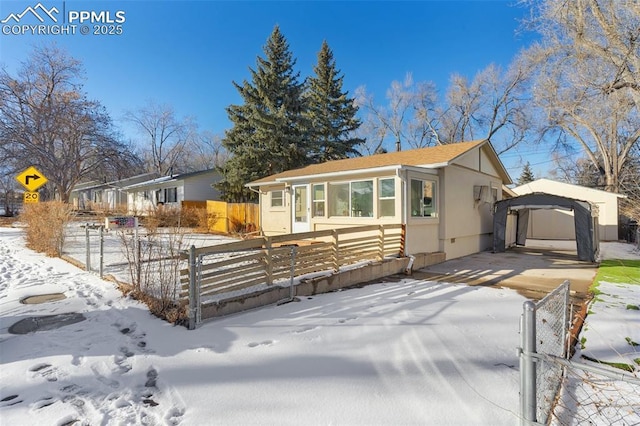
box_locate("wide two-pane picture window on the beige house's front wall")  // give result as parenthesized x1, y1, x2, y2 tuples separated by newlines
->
(328, 180, 373, 217)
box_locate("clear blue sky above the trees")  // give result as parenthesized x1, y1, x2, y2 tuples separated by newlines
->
(0, 0, 550, 179)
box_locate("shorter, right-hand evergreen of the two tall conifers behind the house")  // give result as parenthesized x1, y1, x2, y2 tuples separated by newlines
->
(306, 41, 364, 163)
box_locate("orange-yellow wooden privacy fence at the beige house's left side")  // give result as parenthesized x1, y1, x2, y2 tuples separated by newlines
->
(207, 200, 260, 234)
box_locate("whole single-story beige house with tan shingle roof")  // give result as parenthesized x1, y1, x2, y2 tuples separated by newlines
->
(247, 140, 511, 259)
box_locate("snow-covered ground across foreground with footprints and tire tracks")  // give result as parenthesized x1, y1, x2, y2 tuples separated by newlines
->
(0, 228, 640, 425)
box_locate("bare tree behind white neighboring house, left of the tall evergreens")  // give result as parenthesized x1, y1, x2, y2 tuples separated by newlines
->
(125, 102, 195, 176)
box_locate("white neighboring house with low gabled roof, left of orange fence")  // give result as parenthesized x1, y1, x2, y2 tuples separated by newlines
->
(122, 169, 220, 214)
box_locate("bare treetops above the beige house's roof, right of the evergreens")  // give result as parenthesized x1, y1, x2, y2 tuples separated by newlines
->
(358, 61, 531, 154)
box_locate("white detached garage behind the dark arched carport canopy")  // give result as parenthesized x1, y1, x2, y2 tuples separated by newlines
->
(512, 179, 626, 241)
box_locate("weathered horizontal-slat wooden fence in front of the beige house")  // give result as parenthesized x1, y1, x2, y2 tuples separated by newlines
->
(180, 224, 405, 328)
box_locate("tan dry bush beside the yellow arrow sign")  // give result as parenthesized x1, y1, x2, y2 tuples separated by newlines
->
(19, 201, 73, 257)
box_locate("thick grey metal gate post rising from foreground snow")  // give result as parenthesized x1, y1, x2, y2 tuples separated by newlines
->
(520, 300, 537, 425)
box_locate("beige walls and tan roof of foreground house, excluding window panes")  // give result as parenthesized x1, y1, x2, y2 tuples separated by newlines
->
(248, 142, 511, 258)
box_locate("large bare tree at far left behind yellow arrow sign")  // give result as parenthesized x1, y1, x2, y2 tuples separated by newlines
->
(0, 45, 131, 202)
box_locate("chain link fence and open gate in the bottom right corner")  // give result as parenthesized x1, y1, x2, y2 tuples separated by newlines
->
(520, 281, 640, 426)
